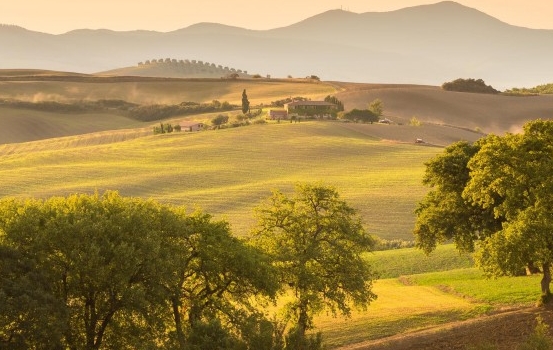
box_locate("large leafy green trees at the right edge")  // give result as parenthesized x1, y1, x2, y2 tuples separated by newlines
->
(414, 120, 553, 297)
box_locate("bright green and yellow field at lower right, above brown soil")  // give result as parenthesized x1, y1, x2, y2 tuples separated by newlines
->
(316, 245, 541, 349)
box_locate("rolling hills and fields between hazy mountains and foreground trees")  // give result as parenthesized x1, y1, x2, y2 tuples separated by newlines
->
(0, 71, 553, 240)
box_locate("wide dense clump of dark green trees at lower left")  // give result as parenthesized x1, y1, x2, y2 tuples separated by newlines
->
(0, 192, 278, 349)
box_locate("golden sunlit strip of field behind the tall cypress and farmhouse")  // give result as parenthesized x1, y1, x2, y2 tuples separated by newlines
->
(0, 78, 336, 105)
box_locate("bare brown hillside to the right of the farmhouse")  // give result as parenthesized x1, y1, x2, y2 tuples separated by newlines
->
(336, 83, 553, 135)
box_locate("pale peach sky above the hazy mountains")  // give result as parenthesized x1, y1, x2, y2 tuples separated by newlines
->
(0, 0, 553, 34)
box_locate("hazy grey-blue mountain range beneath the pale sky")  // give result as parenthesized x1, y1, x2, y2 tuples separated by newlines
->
(0, 1, 553, 89)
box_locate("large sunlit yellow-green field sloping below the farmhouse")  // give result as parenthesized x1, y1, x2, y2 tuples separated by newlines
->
(0, 121, 440, 240)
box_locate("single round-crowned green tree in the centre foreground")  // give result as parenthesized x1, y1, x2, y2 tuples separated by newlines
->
(252, 184, 376, 339)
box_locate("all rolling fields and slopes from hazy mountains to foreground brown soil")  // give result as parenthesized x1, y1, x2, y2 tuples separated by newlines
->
(0, 70, 553, 350)
